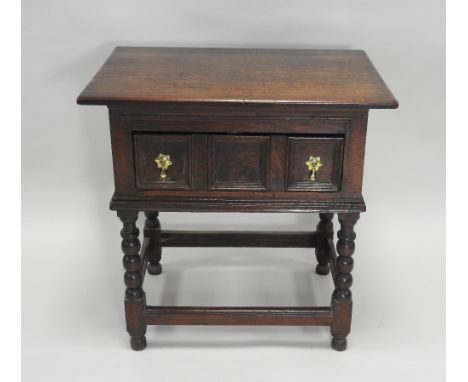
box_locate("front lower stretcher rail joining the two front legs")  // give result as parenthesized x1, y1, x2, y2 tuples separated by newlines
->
(143, 306, 333, 326)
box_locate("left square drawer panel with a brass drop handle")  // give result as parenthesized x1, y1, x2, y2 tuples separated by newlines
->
(133, 133, 192, 190)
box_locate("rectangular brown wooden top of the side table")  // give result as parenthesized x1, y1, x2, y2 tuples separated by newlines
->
(77, 47, 398, 109)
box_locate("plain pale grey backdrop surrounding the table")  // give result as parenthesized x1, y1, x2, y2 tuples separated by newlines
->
(22, 0, 445, 382)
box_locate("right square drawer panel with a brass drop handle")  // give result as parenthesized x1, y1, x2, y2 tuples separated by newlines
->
(286, 136, 344, 192)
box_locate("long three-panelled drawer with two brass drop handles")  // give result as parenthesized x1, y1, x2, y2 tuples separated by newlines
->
(133, 132, 344, 193)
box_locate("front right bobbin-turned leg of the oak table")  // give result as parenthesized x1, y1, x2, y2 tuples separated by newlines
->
(331, 213, 359, 350)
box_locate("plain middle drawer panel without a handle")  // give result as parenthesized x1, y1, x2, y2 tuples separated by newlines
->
(208, 135, 270, 190)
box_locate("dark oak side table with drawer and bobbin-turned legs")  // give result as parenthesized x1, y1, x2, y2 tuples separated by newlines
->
(77, 47, 398, 350)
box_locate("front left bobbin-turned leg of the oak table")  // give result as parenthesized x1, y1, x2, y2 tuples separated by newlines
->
(117, 211, 146, 350)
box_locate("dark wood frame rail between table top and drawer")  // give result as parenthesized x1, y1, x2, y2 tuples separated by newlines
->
(122, 115, 350, 134)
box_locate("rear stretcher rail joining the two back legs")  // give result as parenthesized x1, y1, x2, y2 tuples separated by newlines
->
(161, 231, 318, 248)
